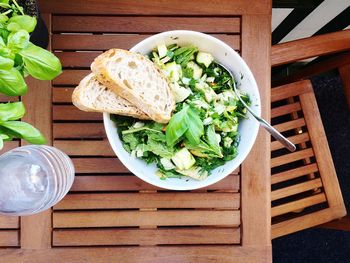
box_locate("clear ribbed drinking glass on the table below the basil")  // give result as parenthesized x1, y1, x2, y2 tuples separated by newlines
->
(0, 145, 74, 216)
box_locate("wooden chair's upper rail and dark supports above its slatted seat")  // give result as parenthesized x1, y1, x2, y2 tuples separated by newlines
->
(271, 29, 350, 106)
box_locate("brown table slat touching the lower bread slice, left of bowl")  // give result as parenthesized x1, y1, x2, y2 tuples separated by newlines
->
(52, 105, 102, 121)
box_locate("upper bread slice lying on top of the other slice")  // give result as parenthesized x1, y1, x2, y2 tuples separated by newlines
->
(91, 49, 175, 123)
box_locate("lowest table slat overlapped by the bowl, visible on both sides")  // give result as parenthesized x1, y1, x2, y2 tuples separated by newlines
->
(71, 174, 240, 192)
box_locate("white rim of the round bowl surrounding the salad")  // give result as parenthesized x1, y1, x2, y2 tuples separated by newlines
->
(103, 30, 261, 190)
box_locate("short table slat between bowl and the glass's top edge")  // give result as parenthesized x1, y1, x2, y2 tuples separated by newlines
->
(53, 140, 115, 156)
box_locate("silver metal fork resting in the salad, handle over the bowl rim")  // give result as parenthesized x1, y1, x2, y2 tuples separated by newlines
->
(216, 62, 296, 152)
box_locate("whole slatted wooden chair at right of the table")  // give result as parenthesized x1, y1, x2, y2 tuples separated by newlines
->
(271, 30, 350, 238)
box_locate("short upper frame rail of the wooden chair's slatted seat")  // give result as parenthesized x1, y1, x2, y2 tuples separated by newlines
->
(271, 80, 312, 102)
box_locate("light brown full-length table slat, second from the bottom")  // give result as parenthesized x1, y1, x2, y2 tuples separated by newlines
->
(53, 210, 240, 228)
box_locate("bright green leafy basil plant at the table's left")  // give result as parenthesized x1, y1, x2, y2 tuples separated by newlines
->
(0, 0, 62, 149)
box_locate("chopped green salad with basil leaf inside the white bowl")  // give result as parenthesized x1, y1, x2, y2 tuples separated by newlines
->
(112, 44, 250, 180)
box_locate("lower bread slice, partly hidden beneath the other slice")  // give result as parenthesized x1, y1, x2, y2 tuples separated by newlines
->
(72, 73, 151, 120)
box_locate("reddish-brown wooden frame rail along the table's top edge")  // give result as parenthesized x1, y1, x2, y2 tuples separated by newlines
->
(40, 0, 271, 16)
